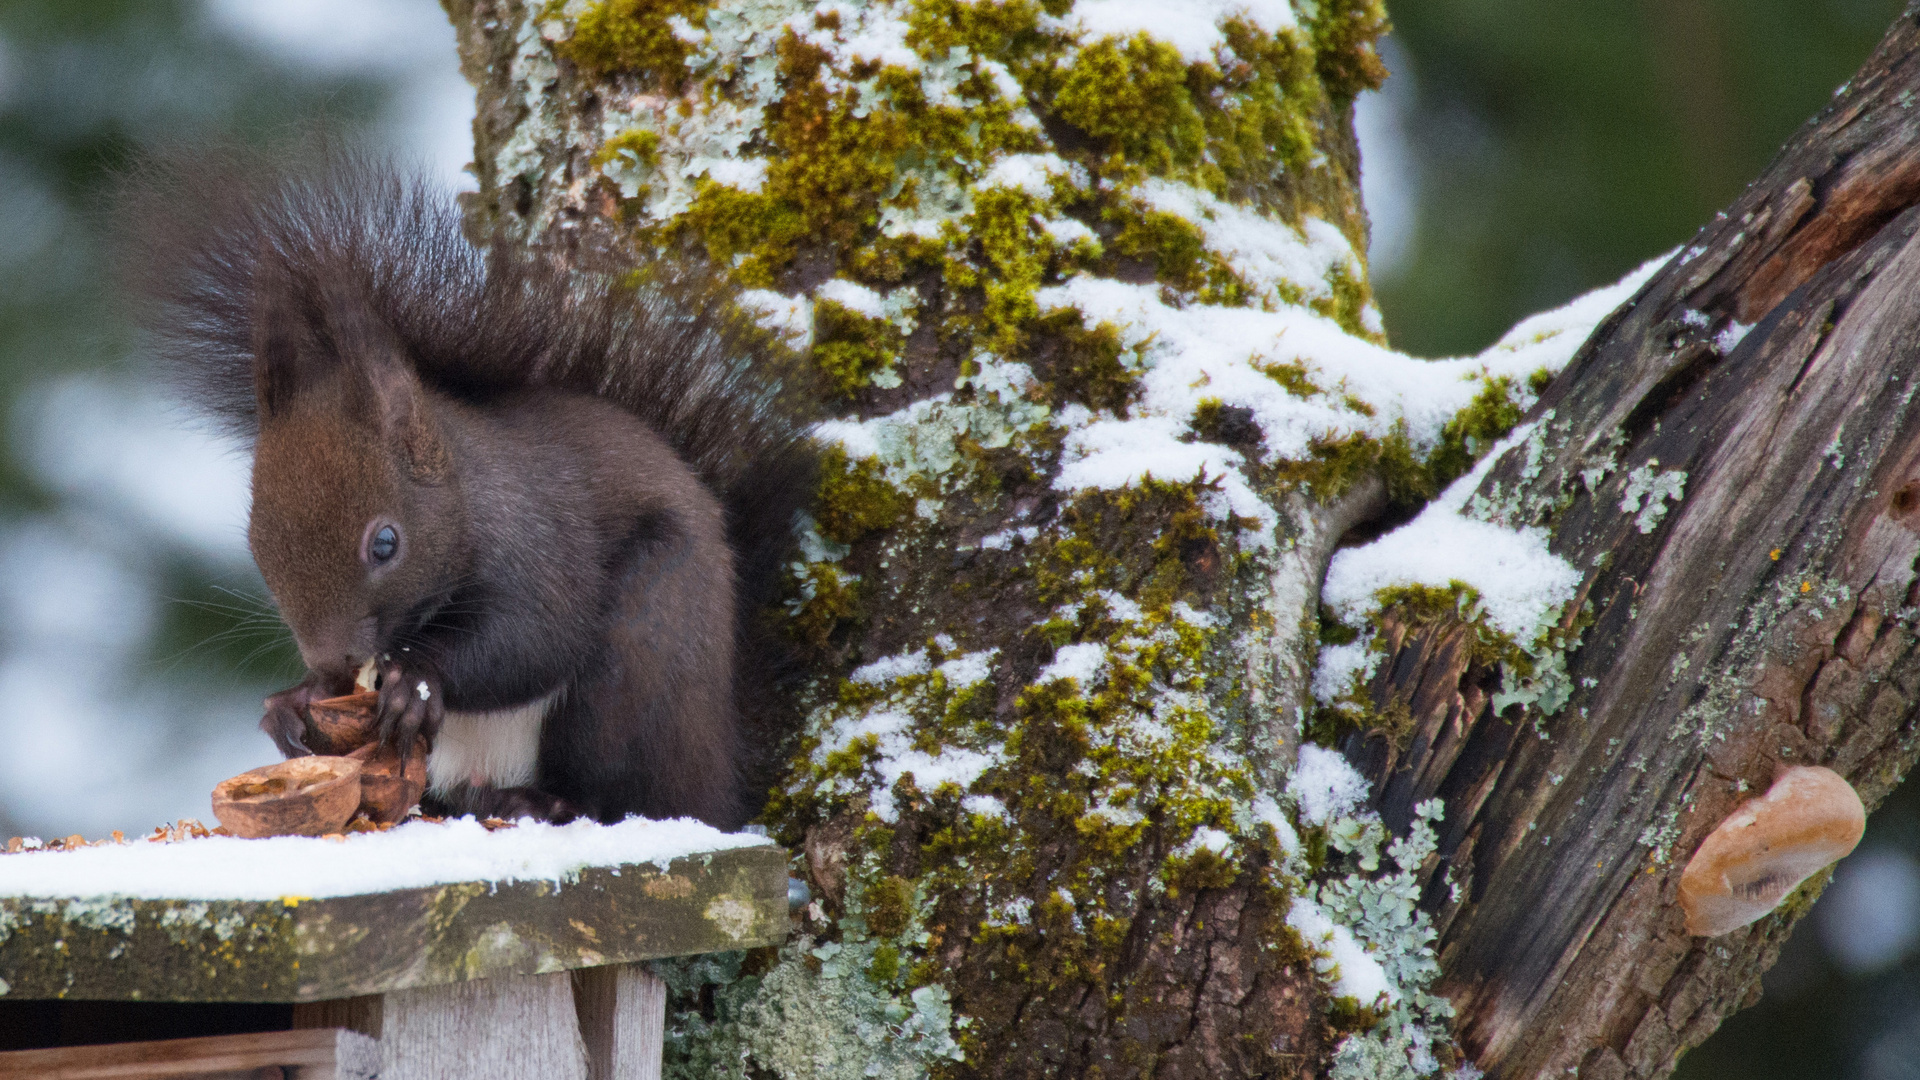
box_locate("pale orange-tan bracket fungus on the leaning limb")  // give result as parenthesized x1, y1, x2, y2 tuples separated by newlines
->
(1680, 765, 1866, 938)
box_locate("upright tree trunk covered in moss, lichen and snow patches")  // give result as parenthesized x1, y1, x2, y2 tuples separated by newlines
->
(445, 0, 1758, 1080)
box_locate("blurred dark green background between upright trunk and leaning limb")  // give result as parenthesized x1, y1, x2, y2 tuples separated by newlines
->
(1369, 0, 1901, 356)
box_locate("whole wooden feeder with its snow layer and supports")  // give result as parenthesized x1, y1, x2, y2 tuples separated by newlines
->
(0, 819, 787, 1080)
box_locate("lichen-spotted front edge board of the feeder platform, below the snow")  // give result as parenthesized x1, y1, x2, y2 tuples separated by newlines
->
(0, 846, 787, 1001)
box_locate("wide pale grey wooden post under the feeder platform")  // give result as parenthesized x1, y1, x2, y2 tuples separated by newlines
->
(380, 972, 588, 1080)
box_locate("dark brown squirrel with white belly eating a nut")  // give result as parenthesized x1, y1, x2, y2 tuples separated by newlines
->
(110, 148, 812, 828)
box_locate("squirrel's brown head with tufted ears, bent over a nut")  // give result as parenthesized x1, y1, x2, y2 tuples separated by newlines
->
(248, 258, 465, 684)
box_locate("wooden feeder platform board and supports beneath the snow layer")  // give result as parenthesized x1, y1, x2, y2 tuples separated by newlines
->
(0, 826, 787, 1080)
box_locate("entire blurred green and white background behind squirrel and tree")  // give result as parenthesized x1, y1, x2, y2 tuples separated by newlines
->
(0, 0, 1920, 1080)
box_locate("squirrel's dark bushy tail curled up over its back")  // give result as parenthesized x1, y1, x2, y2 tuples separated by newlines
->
(117, 142, 820, 799)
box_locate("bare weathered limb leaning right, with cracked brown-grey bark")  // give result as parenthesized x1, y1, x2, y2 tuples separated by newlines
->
(1348, 8, 1920, 1078)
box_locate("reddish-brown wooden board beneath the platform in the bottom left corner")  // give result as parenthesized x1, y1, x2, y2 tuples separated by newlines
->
(0, 1028, 376, 1080)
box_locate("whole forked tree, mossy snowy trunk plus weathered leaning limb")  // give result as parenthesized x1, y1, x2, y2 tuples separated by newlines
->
(445, 0, 1914, 1080)
